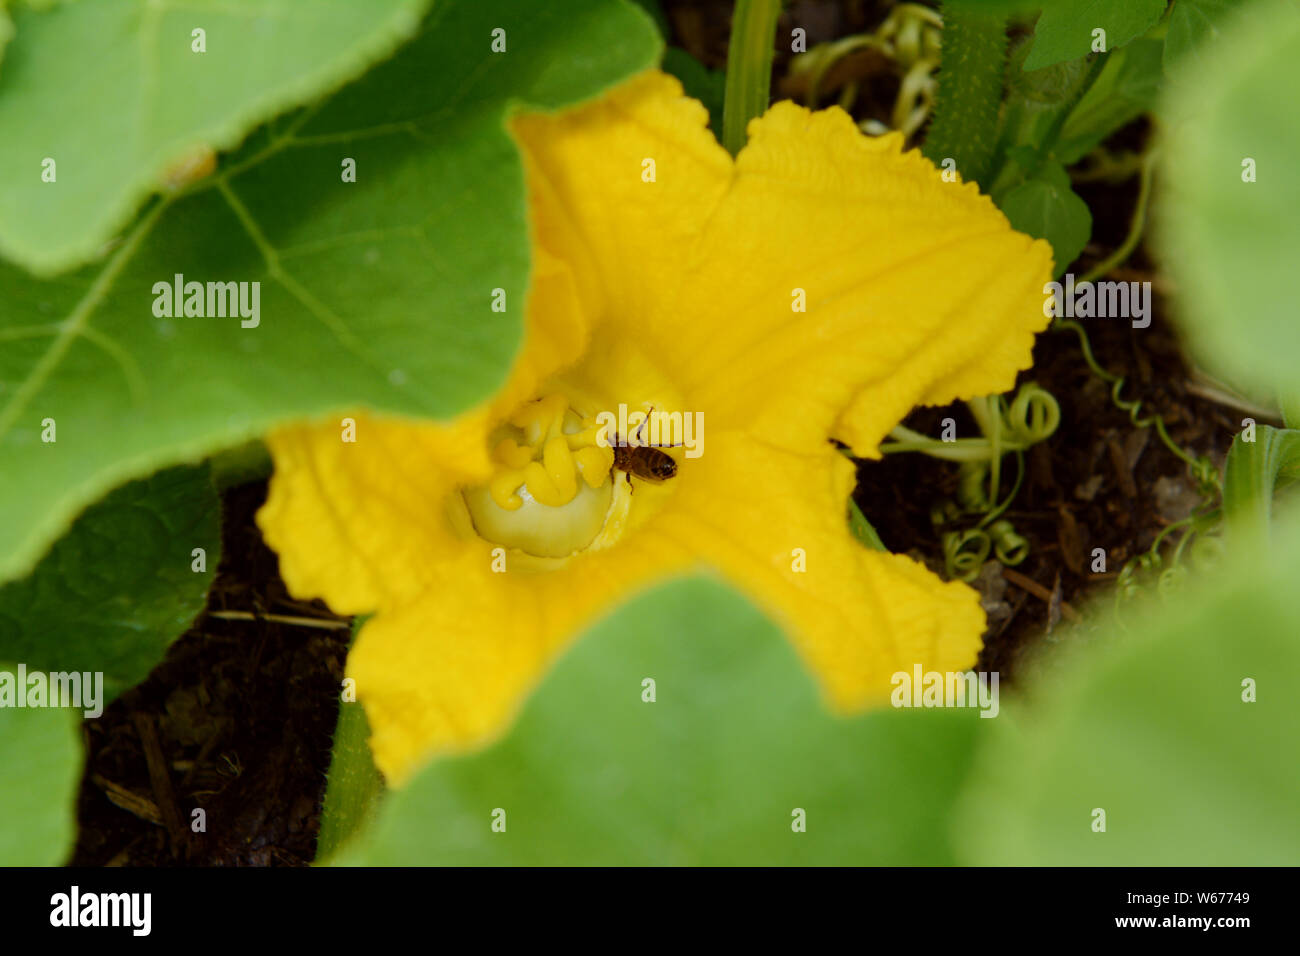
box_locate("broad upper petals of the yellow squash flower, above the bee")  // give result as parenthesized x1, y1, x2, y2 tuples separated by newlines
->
(515, 74, 1052, 455)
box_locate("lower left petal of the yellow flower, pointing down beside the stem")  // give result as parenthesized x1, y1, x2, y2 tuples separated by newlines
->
(347, 532, 690, 786)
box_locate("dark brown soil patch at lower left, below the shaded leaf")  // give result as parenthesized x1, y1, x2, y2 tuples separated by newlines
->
(73, 483, 351, 866)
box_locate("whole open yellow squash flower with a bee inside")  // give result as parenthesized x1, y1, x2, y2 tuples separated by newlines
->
(259, 72, 1052, 784)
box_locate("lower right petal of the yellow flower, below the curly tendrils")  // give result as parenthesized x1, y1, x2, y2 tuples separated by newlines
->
(655, 433, 984, 710)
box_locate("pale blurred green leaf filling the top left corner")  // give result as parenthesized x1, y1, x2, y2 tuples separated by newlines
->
(0, 0, 428, 276)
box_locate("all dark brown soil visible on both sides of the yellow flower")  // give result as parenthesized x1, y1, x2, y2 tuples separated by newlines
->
(73, 0, 1243, 866)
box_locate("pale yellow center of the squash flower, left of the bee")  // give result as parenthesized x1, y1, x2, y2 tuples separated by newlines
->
(463, 394, 627, 558)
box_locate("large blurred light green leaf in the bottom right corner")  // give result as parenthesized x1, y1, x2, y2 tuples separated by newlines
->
(956, 515, 1300, 866)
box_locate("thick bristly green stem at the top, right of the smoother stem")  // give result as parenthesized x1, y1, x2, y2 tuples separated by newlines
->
(922, 0, 1008, 186)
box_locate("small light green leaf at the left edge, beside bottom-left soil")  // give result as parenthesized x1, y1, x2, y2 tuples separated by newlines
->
(0, 702, 82, 866)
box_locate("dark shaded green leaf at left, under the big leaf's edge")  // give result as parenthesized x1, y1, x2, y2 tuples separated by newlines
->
(0, 467, 221, 698)
